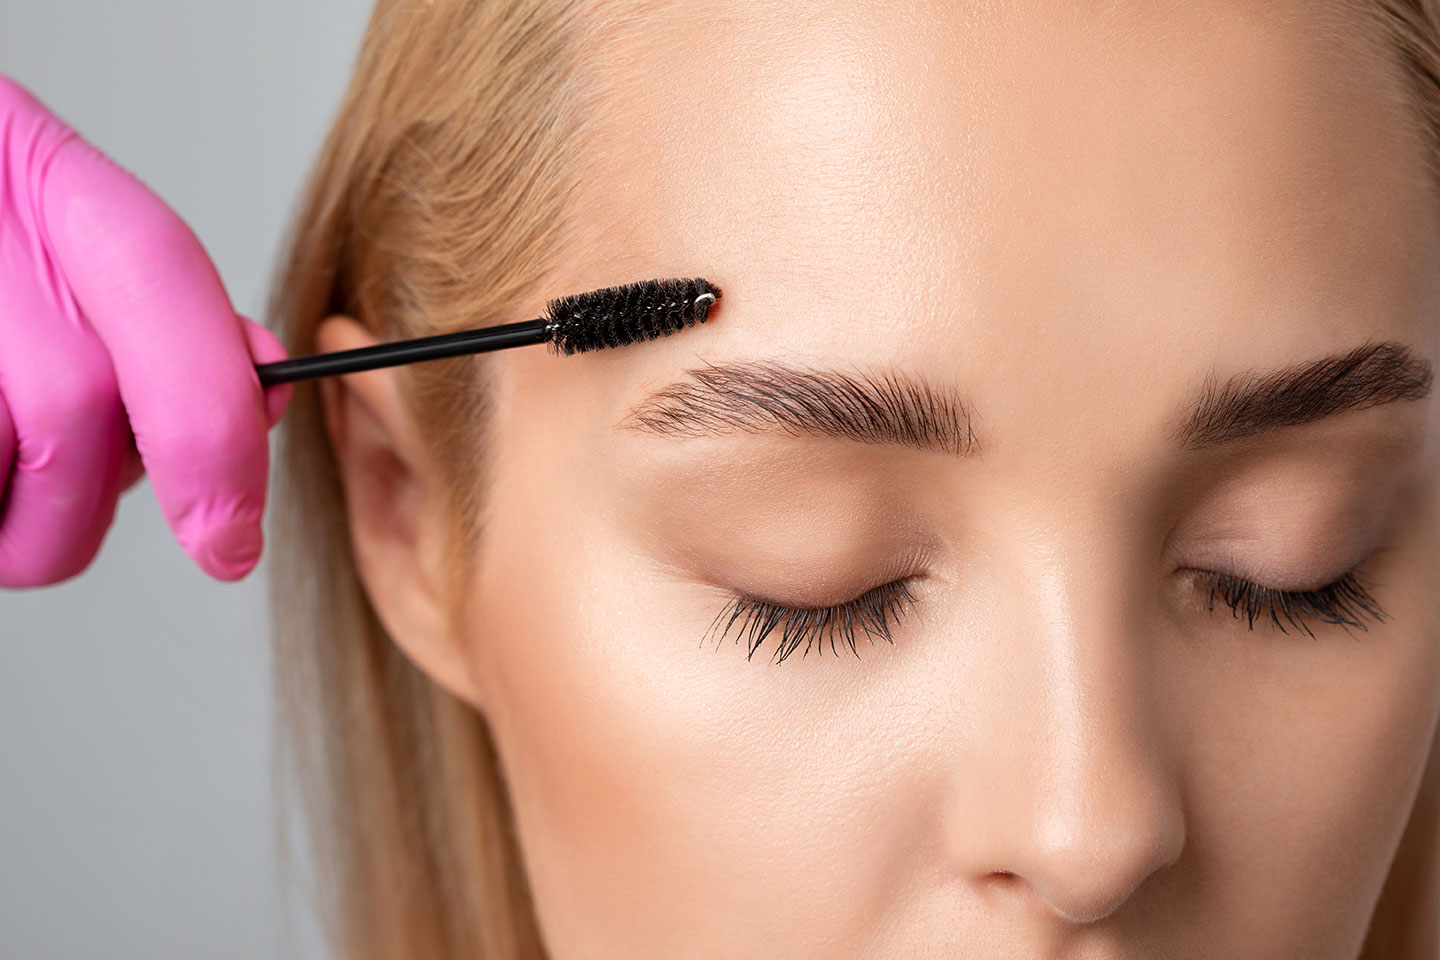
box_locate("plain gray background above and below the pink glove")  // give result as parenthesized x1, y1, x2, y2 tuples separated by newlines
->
(0, 0, 370, 960)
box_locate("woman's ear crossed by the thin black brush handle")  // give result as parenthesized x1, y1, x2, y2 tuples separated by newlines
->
(315, 315, 478, 708)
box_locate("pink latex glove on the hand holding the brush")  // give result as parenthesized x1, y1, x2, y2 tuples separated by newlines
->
(0, 75, 291, 587)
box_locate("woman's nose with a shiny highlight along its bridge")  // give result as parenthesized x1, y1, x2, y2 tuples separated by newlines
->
(950, 518, 1184, 923)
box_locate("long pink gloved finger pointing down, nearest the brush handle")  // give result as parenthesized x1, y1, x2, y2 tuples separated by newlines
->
(43, 137, 269, 580)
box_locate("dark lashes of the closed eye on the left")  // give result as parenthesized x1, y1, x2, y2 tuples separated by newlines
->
(700, 579, 914, 664)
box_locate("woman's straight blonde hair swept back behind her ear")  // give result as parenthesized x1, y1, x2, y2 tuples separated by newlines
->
(269, 0, 1440, 960)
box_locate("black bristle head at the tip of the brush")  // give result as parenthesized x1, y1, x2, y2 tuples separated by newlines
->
(543, 276, 720, 354)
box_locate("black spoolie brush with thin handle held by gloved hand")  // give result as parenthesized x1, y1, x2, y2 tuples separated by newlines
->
(255, 278, 720, 387)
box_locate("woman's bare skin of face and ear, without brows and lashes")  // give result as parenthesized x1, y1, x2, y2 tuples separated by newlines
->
(320, 0, 1440, 960)
